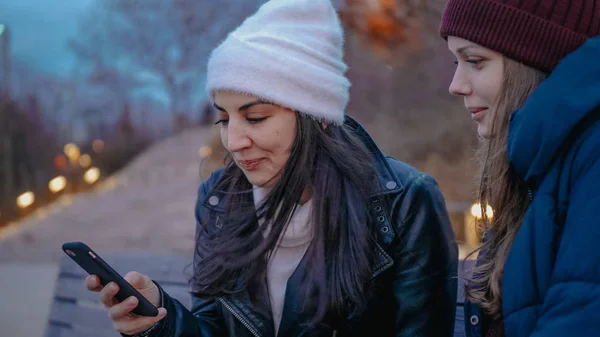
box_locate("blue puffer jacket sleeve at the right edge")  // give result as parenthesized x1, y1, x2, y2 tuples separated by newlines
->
(531, 145, 600, 337)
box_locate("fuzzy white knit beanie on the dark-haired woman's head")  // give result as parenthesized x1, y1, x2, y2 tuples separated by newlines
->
(206, 0, 350, 124)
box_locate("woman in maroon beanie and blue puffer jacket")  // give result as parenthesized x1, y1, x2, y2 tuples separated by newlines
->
(440, 0, 600, 337)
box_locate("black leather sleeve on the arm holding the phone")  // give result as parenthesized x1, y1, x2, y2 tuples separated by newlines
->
(137, 175, 226, 337)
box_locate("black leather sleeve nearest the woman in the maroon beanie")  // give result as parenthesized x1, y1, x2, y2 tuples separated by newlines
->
(393, 174, 458, 337)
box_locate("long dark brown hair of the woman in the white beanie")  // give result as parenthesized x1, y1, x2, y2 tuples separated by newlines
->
(192, 113, 376, 323)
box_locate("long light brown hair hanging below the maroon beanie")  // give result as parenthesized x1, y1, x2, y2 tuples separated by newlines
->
(465, 58, 546, 317)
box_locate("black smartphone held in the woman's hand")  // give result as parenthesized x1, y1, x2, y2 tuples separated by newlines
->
(62, 242, 158, 317)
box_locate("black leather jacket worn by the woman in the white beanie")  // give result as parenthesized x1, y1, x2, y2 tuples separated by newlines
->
(143, 118, 458, 337)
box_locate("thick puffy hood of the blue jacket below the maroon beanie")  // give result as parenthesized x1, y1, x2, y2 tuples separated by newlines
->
(507, 36, 600, 188)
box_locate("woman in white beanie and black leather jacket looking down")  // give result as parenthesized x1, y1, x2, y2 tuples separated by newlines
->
(86, 0, 458, 337)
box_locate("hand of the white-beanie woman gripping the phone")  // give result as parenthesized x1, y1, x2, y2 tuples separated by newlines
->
(85, 272, 167, 335)
